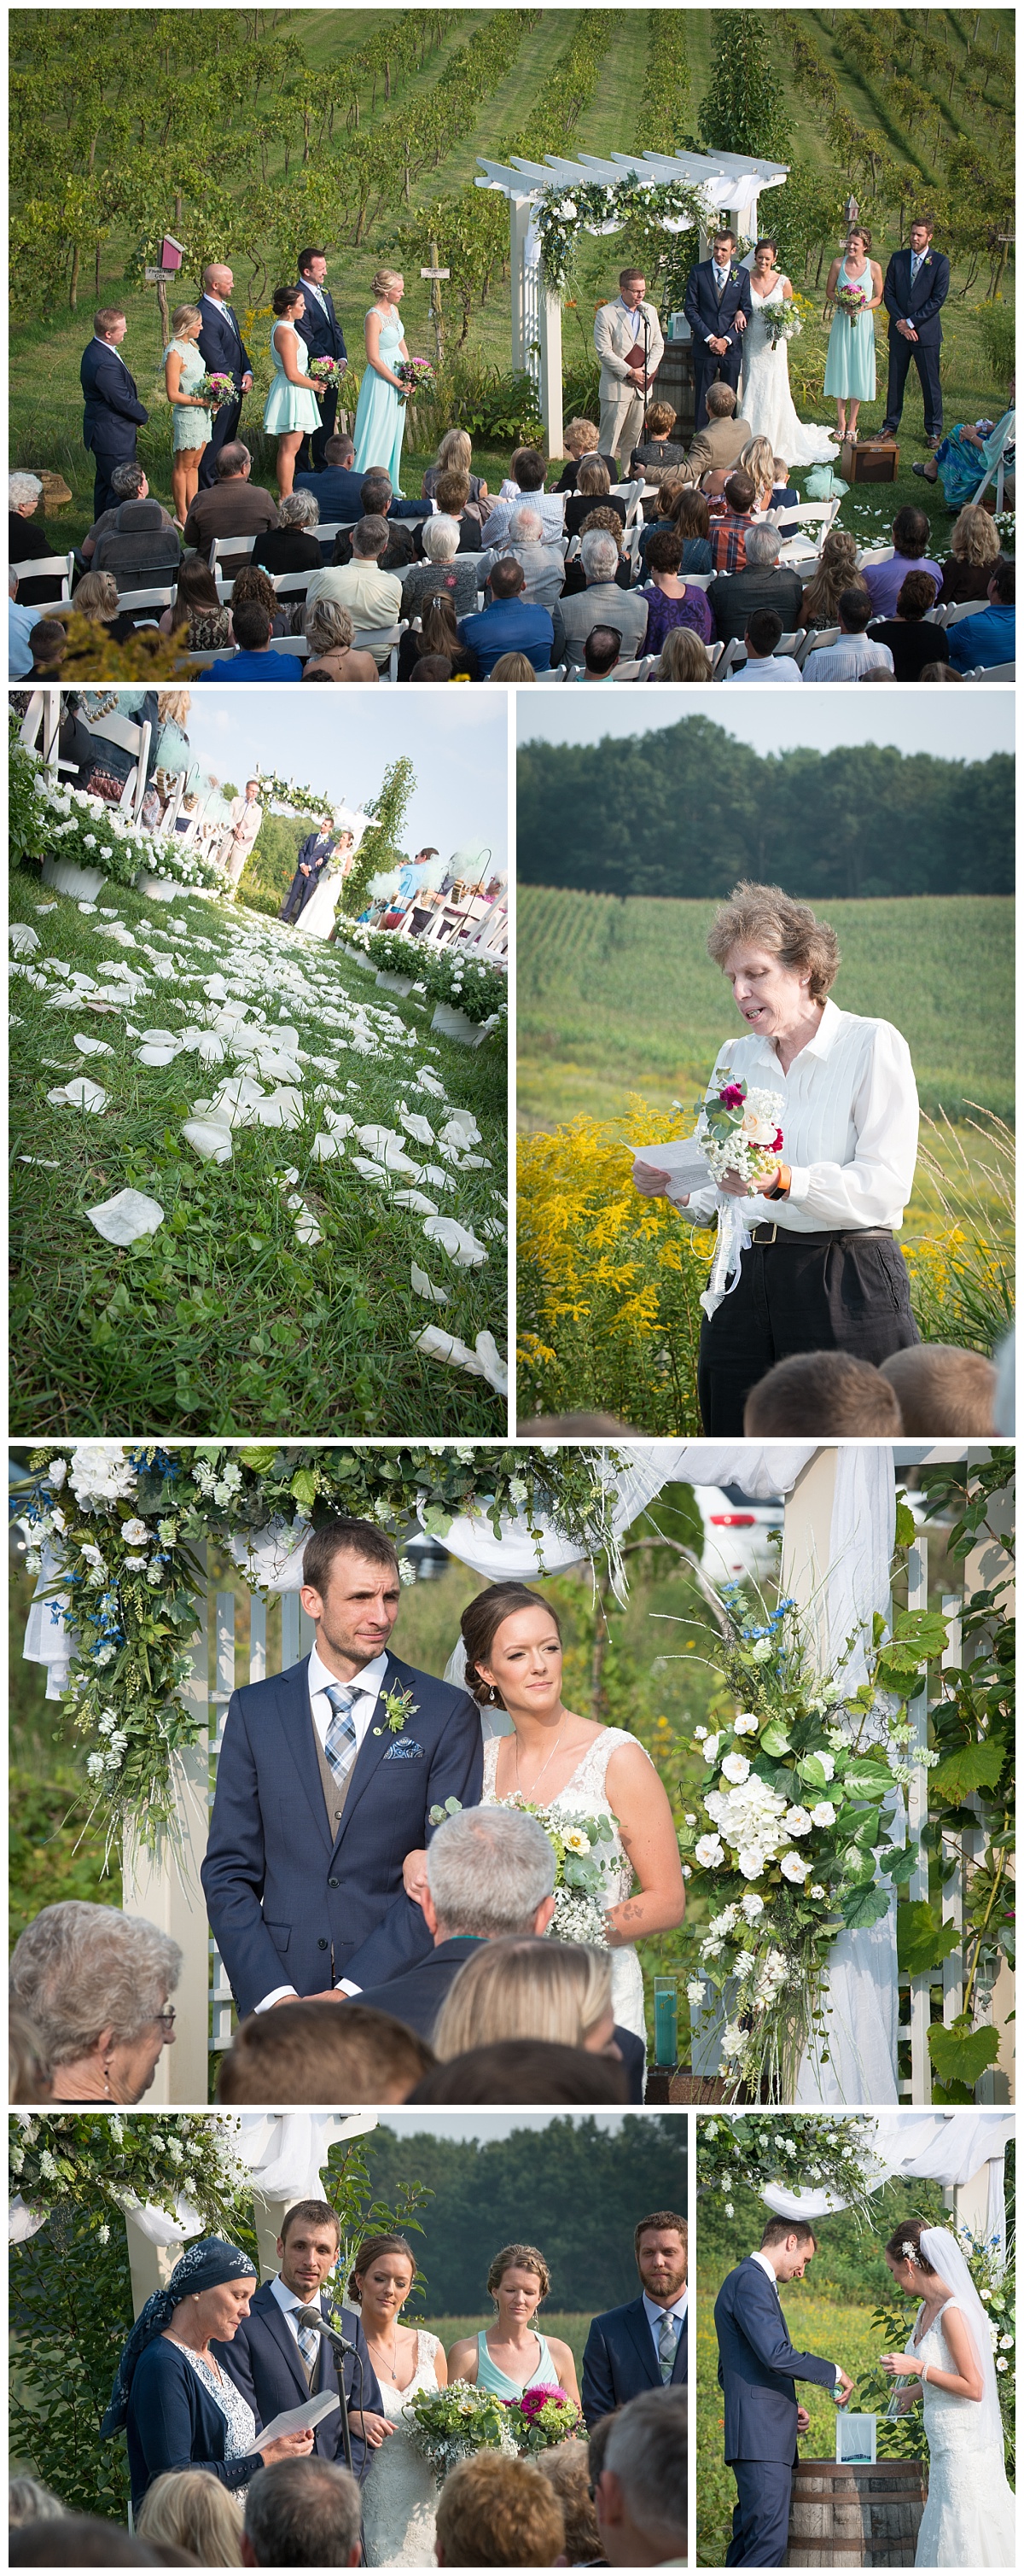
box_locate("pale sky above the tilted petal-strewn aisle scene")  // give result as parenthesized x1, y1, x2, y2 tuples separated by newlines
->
(188, 685, 509, 868)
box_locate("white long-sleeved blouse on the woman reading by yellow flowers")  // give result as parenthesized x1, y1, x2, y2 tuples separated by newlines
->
(684, 1002, 918, 1234)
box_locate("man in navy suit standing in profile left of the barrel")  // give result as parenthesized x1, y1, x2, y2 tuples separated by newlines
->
(715, 2218, 854, 2568)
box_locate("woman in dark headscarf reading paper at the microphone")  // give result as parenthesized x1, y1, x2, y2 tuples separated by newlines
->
(101, 2236, 311, 2515)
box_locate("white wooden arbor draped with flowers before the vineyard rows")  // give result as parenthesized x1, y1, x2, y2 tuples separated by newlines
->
(476, 152, 790, 456)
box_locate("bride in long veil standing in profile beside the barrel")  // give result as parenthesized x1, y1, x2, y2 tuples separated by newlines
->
(882, 2218, 1016, 2568)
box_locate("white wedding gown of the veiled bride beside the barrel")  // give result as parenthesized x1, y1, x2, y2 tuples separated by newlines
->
(911, 2308, 1016, 2568)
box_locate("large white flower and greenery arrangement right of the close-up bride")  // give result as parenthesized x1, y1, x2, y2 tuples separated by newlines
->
(679, 1589, 947, 2102)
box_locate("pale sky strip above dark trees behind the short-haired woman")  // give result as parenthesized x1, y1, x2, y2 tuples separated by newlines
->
(517, 680, 1014, 760)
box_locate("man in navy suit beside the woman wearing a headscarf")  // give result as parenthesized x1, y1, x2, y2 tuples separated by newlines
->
(213, 2200, 386, 2478)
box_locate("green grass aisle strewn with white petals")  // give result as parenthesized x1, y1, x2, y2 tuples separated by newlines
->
(10, 873, 507, 1437)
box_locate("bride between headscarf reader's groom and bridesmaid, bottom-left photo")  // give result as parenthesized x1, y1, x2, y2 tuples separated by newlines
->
(350, 2236, 448, 2568)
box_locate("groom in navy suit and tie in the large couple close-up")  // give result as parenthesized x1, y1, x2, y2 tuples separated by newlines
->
(203, 1520, 484, 2014)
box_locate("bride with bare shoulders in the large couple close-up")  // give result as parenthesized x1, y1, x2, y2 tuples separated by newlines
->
(406, 1582, 684, 2037)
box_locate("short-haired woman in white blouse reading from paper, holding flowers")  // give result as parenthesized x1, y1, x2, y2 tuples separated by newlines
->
(633, 881, 921, 1437)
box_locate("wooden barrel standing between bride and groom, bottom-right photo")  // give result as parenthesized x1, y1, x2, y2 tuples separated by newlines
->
(788, 2460, 926, 2568)
